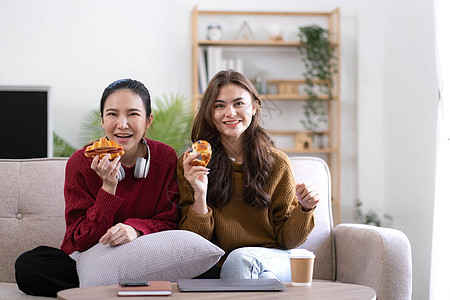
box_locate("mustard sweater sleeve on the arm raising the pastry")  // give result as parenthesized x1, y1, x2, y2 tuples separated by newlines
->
(177, 156, 214, 240)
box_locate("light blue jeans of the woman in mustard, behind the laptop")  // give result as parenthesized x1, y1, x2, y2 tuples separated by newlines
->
(220, 247, 291, 281)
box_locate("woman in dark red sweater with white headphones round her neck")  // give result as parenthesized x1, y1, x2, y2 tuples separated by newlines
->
(15, 79, 179, 297)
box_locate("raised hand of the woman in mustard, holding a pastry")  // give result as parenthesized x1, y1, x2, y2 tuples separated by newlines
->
(183, 149, 209, 214)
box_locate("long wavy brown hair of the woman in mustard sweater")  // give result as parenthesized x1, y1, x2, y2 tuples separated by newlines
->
(191, 70, 274, 208)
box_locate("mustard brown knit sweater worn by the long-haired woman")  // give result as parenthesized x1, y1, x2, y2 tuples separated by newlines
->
(177, 149, 314, 254)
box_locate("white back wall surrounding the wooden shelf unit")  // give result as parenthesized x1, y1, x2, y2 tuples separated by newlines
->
(0, 0, 357, 220)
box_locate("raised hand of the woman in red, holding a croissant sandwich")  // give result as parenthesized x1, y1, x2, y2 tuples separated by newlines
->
(91, 154, 121, 195)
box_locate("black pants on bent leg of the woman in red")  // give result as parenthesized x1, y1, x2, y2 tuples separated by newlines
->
(15, 246, 80, 297)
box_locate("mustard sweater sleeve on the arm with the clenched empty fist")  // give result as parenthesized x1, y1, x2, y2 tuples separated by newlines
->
(271, 151, 314, 249)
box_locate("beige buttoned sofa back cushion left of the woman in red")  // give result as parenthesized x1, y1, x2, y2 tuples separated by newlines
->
(0, 158, 67, 282)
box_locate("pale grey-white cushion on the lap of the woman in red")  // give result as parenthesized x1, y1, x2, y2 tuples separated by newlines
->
(70, 230, 225, 287)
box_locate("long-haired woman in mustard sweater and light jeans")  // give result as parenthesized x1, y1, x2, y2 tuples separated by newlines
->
(177, 70, 319, 281)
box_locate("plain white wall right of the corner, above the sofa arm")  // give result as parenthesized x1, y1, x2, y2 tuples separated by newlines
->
(358, 0, 437, 299)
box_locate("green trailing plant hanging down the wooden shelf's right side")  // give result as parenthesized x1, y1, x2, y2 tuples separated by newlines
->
(298, 25, 337, 144)
